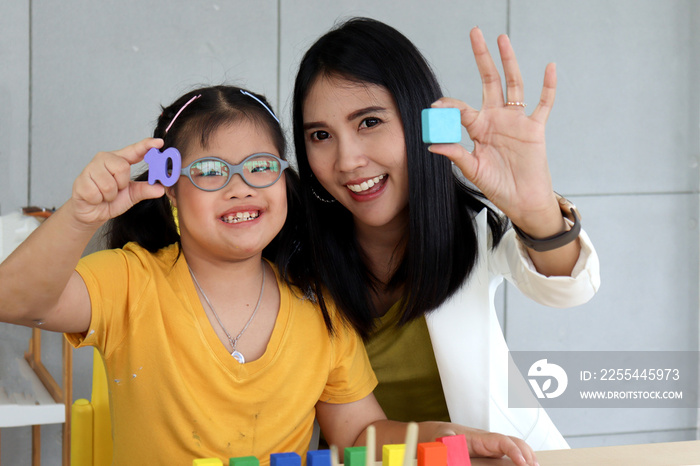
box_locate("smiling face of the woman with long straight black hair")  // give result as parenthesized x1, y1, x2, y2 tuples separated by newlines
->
(303, 75, 408, 233)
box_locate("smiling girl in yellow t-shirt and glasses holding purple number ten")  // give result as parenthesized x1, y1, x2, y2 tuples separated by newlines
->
(0, 86, 534, 464)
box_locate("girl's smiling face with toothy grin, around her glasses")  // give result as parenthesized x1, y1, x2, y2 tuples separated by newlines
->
(168, 119, 287, 260)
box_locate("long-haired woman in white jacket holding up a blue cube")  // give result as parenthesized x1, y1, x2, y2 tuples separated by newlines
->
(293, 18, 599, 450)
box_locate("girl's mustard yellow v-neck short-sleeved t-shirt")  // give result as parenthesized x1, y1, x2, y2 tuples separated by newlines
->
(67, 243, 376, 465)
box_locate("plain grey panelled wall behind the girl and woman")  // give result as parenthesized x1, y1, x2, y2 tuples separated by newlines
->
(0, 0, 700, 465)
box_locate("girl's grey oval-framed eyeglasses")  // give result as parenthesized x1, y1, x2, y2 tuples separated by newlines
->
(180, 153, 289, 191)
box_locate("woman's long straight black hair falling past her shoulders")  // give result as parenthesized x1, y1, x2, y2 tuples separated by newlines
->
(292, 18, 507, 338)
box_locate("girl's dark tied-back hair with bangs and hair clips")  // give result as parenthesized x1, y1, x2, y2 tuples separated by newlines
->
(106, 86, 304, 316)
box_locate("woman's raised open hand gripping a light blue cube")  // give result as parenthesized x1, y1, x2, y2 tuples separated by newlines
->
(430, 28, 561, 231)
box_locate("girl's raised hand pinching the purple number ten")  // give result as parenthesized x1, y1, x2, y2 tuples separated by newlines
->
(71, 138, 165, 226)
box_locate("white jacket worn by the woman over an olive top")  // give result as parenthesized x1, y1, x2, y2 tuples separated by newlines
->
(426, 210, 600, 450)
